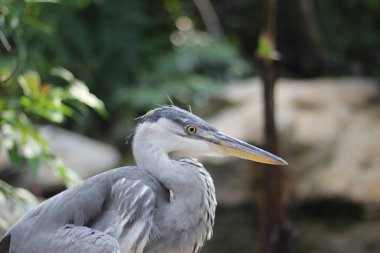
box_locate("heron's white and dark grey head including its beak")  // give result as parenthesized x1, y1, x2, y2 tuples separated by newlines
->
(133, 106, 287, 165)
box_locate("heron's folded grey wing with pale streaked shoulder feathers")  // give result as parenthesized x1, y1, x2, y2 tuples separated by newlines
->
(0, 167, 157, 253)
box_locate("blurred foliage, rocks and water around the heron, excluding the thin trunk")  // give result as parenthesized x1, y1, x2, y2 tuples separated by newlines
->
(0, 0, 380, 253)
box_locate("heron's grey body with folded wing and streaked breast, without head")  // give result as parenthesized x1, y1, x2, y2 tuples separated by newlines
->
(2, 163, 216, 253)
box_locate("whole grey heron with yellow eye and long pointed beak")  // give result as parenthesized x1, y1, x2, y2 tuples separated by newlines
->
(0, 106, 287, 253)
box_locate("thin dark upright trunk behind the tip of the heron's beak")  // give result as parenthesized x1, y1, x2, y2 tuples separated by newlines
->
(254, 0, 291, 253)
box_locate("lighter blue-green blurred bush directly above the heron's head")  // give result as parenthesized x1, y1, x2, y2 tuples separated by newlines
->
(115, 17, 249, 111)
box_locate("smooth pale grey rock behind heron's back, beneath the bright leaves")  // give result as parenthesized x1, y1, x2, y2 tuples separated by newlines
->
(3, 126, 120, 191)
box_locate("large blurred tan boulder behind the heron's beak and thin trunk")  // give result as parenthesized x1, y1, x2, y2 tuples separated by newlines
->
(203, 78, 380, 204)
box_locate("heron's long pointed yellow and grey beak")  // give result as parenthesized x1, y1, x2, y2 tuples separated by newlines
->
(208, 132, 288, 165)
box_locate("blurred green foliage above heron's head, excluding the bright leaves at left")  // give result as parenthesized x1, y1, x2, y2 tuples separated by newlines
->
(0, 0, 249, 140)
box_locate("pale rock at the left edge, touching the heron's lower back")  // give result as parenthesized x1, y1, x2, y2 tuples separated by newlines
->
(0, 180, 39, 235)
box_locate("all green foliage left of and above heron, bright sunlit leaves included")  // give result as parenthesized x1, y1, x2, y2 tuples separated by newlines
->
(0, 0, 249, 176)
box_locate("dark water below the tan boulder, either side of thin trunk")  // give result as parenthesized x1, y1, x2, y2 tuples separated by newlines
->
(201, 205, 380, 253)
